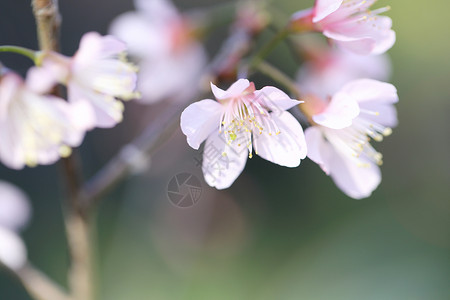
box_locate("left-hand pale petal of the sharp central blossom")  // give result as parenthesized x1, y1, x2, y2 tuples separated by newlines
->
(180, 99, 222, 149)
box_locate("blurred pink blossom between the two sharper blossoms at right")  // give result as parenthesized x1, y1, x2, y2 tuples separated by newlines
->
(297, 48, 391, 99)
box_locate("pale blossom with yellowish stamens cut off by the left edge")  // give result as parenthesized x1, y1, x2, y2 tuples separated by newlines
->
(0, 72, 84, 169)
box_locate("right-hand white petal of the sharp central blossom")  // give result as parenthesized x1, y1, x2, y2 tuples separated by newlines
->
(253, 112, 307, 167)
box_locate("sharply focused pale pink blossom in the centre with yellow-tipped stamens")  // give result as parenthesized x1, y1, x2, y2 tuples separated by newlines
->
(181, 79, 306, 189)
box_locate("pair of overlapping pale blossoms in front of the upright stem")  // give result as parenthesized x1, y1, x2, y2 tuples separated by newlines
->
(0, 32, 137, 169)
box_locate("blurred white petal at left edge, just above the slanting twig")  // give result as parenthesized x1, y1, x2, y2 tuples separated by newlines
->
(0, 227, 27, 271)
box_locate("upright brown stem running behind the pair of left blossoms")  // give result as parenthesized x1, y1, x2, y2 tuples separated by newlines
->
(32, 0, 94, 300)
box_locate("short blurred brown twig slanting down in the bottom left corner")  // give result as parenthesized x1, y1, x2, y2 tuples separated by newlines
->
(15, 264, 73, 300)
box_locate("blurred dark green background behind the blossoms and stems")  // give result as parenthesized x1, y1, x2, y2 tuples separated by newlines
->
(0, 0, 450, 300)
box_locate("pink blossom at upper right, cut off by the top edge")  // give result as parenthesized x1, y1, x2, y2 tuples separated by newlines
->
(291, 0, 395, 55)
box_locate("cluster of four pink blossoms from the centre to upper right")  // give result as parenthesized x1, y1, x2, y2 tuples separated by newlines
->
(181, 0, 398, 199)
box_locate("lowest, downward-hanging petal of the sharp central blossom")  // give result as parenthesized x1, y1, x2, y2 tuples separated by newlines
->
(202, 133, 248, 190)
